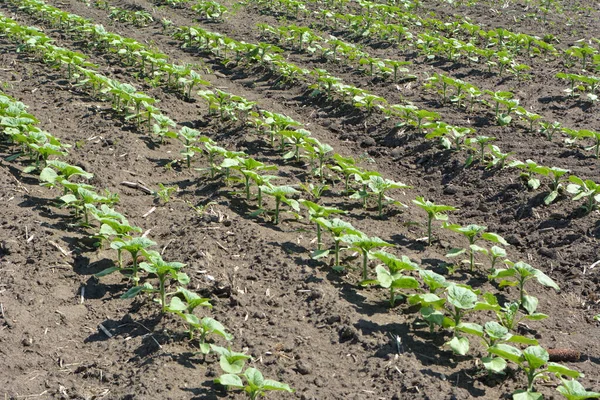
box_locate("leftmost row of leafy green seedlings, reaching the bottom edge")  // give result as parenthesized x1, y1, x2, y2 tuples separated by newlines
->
(0, 11, 292, 398)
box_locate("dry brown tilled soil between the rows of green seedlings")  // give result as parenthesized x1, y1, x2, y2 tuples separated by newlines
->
(0, 0, 600, 399)
